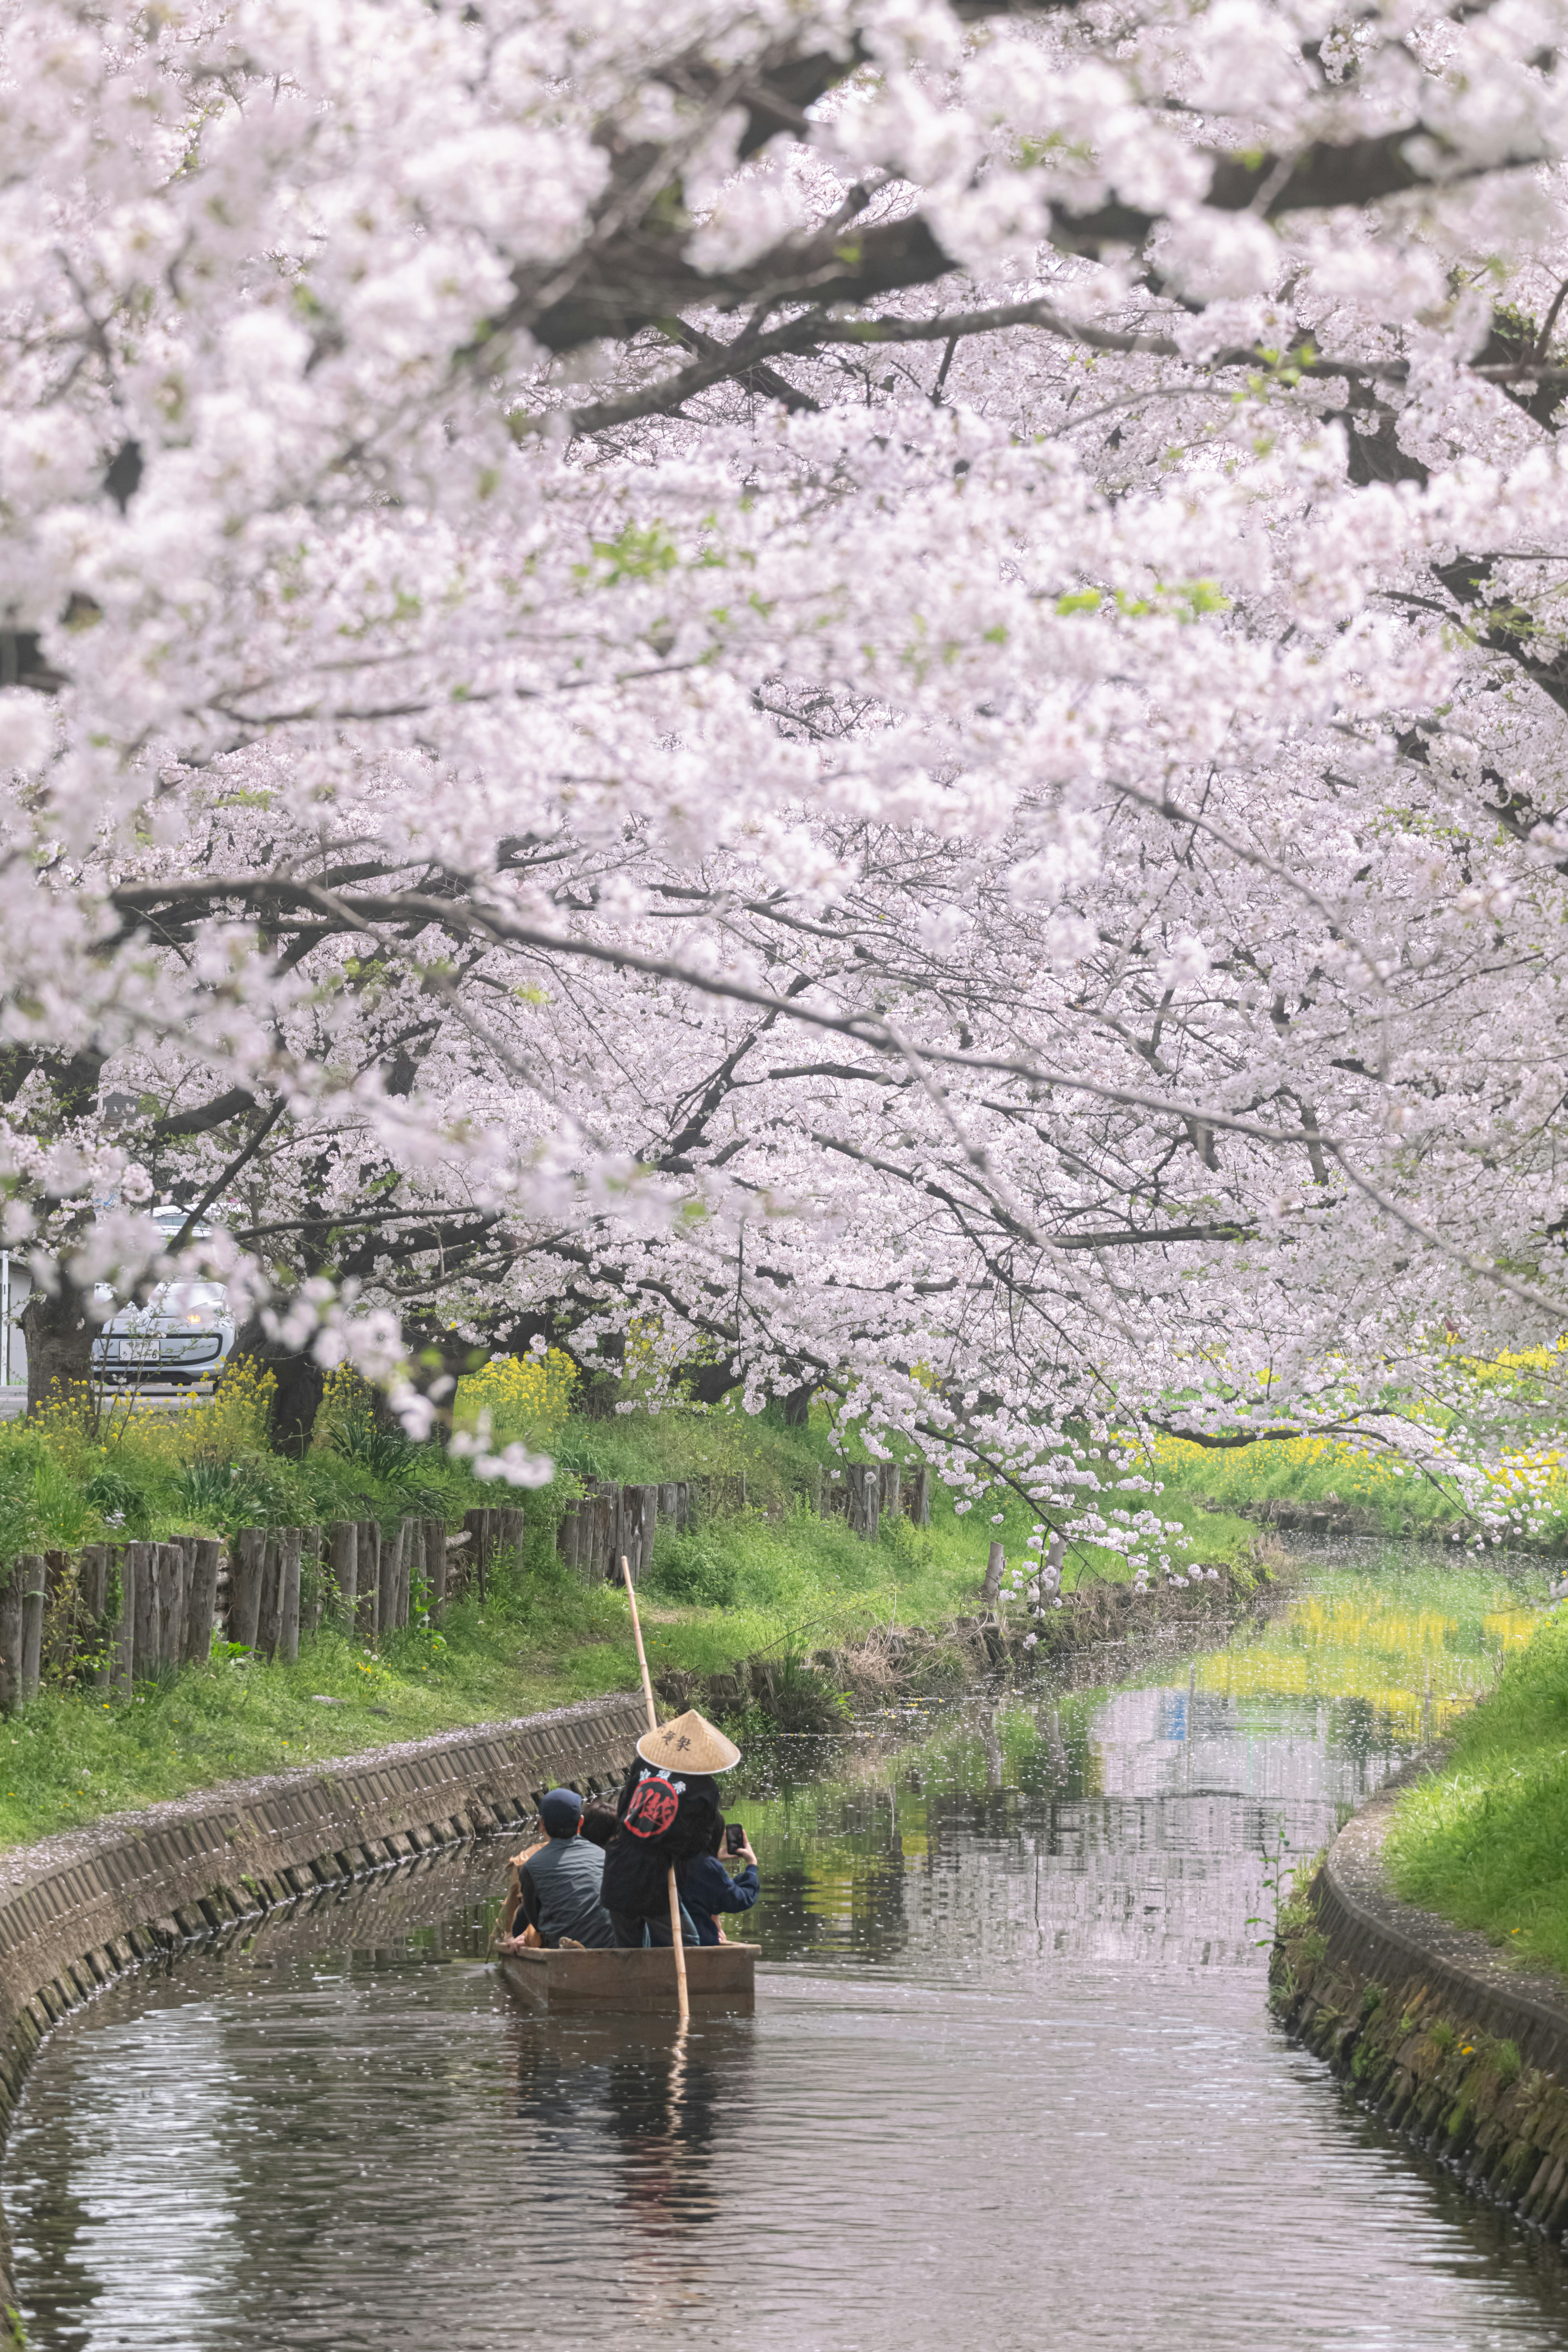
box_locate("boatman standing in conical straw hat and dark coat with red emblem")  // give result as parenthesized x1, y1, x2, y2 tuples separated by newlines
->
(604, 1708, 740, 1945)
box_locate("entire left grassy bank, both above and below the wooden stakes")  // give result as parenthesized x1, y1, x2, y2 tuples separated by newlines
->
(0, 1359, 1255, 1844)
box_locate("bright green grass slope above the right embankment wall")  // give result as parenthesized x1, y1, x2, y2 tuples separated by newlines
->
(1387, 1609, 1568, 1973)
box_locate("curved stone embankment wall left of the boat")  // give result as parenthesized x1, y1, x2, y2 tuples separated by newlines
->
(0, 1696, 646, 2343)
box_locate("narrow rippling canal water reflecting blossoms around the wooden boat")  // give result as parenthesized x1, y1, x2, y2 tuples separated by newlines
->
(5, 1555, 1568, 2352)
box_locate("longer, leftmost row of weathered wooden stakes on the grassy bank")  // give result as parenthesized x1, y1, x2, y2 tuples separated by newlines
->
(0, 1510, 522, 1712)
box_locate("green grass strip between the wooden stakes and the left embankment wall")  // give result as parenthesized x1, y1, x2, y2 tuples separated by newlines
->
(0, 1510, 1025, 1844)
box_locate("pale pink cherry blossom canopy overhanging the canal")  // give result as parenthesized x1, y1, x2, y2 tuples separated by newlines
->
(0, 0, 1568, 1557)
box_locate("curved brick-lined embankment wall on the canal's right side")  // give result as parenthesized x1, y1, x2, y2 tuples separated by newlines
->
(1272, 1783, 1568, 2251)
